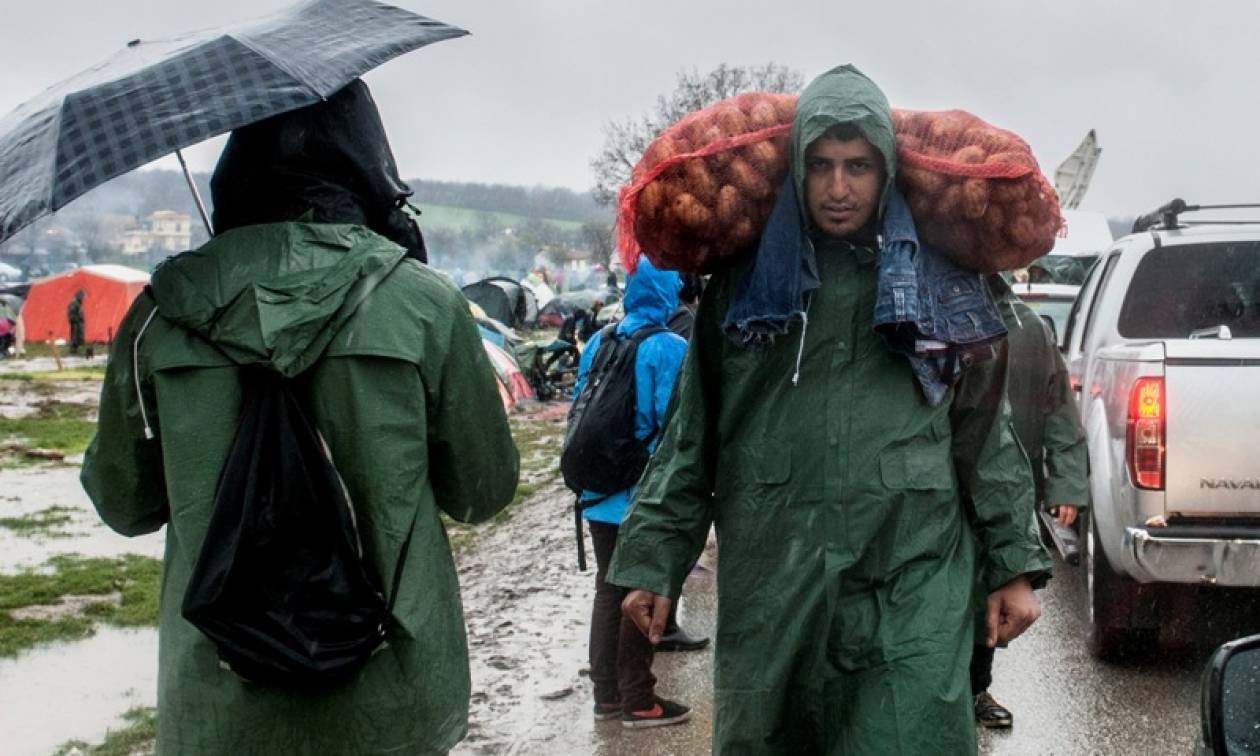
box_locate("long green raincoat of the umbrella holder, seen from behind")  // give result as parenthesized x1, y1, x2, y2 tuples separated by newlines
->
(83, 223, 518, 756)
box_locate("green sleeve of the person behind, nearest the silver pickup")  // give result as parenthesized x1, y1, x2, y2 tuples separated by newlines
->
(1043, 345, 1089, 508)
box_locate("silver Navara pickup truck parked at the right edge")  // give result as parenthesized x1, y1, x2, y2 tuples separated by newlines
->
(1065, 200, 1260, 658)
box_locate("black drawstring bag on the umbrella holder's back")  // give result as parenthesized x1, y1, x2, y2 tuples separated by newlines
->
(183, 367, 389, 689)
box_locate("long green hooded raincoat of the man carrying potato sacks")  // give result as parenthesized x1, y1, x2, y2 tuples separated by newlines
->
(609, 68, 1050, 756)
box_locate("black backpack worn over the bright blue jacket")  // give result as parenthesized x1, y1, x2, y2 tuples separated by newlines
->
(559, 324, 665, 494)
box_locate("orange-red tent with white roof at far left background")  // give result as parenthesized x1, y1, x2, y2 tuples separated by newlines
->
(21, 265, 149, 343)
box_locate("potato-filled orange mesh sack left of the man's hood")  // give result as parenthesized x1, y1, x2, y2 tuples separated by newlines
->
(617, 92, 796, 272)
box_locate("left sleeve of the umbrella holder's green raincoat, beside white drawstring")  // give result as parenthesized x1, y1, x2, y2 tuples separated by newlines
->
(81, 294, 170, 536)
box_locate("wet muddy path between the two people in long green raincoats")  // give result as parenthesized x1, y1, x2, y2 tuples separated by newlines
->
(454, 423, 714, 756)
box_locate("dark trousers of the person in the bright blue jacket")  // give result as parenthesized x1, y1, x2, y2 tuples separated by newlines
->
(587, 520, 656, 711)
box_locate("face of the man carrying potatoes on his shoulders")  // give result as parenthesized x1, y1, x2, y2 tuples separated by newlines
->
(805, 136, 883, 237)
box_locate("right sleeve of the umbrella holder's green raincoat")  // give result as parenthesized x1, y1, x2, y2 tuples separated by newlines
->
(425, 297, 520, 523)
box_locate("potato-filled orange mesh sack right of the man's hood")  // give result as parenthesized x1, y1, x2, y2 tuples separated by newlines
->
(892, 110, 1063, 273)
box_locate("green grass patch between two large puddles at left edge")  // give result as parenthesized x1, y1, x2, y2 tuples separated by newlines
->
(0, 554, 161, 656)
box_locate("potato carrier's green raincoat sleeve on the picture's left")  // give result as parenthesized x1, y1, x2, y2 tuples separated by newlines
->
(606, 286, 725, 599)
